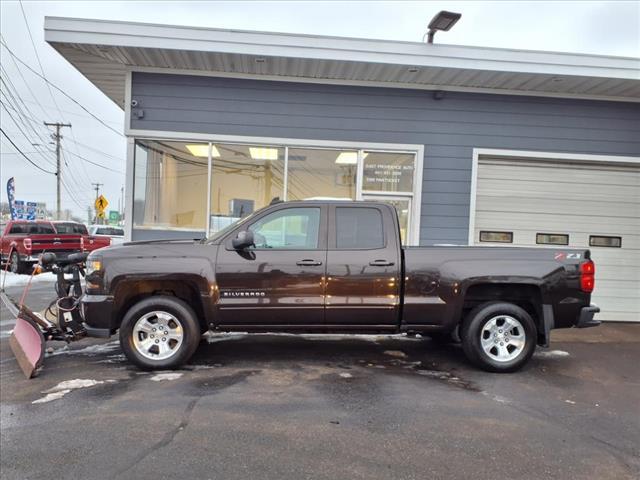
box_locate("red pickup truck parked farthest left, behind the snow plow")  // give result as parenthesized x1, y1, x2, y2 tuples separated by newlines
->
(0, 220, 84, 273)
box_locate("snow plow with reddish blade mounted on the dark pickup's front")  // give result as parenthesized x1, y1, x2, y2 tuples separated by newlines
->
(0, 253, 88, 378)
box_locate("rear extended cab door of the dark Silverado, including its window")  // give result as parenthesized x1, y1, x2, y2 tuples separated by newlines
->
(325, 204, 402, 329)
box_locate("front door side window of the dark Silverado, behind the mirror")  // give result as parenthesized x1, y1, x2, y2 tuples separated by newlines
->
(249, 207, 320, 250)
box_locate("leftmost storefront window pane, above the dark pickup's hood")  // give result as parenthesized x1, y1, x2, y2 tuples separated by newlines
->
(133, 140, 208, 230)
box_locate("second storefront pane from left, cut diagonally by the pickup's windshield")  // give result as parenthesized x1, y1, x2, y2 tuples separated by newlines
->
(210, 143, 285, 233)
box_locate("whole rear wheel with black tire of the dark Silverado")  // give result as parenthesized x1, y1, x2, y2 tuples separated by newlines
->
(462, 302, 537, 373)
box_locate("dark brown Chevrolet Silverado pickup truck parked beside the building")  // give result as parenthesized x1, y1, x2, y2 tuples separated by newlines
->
(82, 201, 599, 372)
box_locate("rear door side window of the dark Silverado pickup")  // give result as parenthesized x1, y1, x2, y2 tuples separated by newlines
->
(336, 207, 384, 249)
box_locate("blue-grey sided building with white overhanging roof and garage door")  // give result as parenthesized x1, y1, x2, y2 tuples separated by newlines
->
(45, 18, 640, 321)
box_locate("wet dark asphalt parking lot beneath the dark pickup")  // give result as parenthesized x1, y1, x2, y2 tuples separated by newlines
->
(0, 283, 640, 479)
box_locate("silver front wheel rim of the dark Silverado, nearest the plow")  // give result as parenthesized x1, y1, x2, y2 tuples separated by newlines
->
(133, 311, 184, 360)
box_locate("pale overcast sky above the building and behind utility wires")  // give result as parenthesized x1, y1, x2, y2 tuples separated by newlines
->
(0, 0, 640, 218)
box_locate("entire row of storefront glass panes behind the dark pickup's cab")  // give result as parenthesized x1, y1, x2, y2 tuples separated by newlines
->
(133, 140, 419, 243)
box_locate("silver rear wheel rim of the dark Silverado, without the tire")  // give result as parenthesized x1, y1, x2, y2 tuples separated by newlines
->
(480, 315, 526, 362)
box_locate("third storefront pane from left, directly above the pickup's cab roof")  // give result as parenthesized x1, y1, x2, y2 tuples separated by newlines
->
(287, 147, 358, 200)
